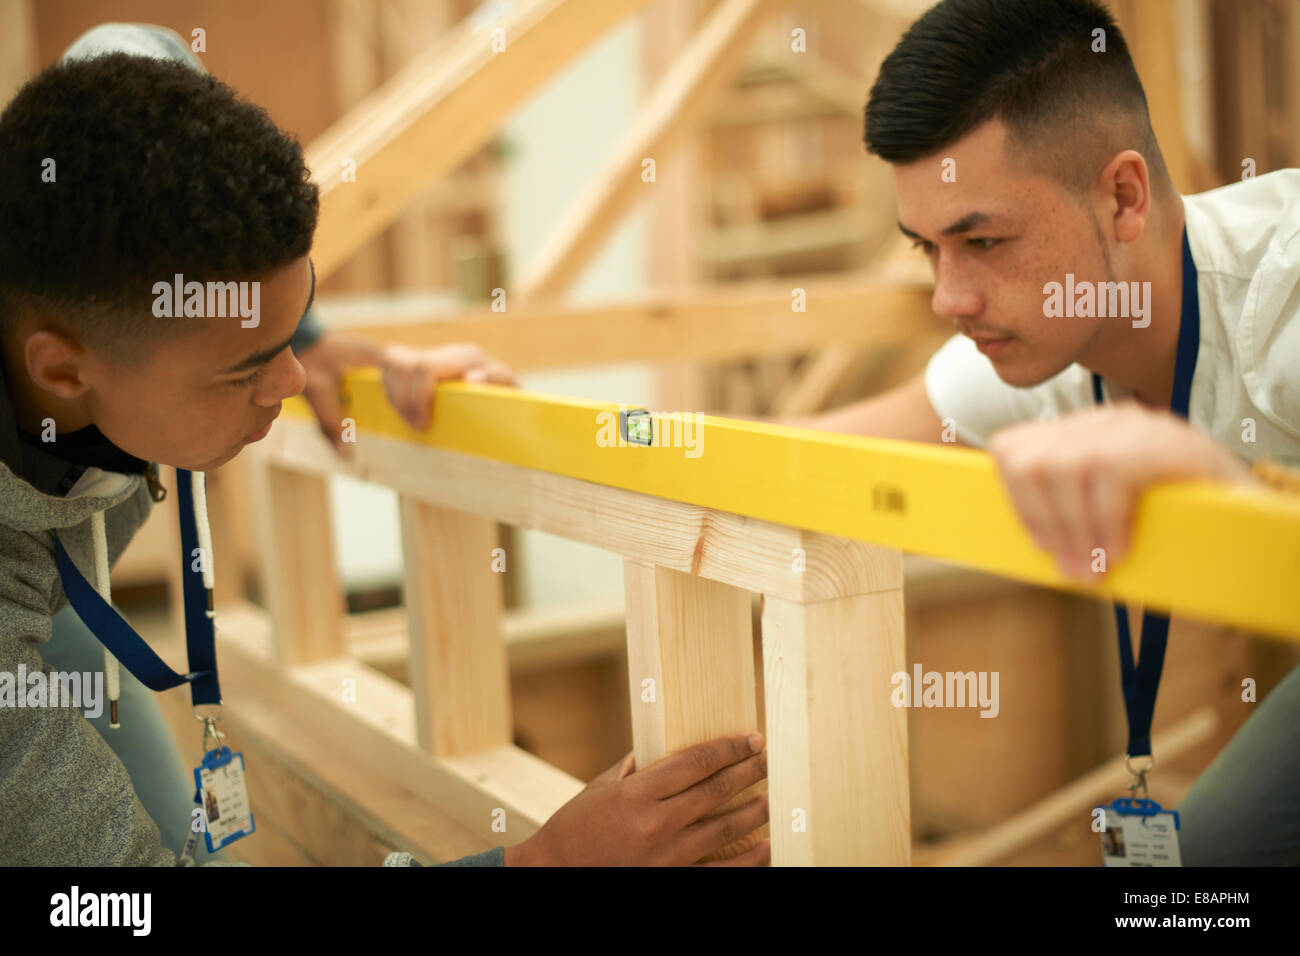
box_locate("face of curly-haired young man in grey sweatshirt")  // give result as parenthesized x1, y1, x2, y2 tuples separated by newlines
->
(83, 256, 316, 471)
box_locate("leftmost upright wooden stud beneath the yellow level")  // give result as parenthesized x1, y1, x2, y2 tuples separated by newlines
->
(251, 463, 347, 665)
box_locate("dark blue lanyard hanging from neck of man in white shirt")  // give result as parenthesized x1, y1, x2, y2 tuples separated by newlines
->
(1092, 228, 1201, 757)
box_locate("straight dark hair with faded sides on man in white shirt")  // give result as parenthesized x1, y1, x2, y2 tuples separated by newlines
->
(865, 0, 1169, 195)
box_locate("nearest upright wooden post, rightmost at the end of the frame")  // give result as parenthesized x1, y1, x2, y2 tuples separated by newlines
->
(763, 545, 911, 866)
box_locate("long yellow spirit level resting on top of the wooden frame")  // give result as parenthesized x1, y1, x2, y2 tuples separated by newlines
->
(282, 369, 1300, 640)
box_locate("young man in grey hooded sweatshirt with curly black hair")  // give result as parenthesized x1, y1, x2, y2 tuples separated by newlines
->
(0, 25, 768, 865)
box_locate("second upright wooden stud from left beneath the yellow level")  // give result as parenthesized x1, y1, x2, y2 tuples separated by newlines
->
(400, 496, 514, 757)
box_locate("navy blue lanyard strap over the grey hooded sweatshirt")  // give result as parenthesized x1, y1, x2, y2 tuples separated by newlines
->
(55, 468, 221, 706)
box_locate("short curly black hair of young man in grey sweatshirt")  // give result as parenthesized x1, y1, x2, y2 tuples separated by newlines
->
(0, 53, 320, 364)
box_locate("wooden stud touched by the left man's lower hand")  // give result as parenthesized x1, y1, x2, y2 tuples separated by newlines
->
(624, 559, 767, 858)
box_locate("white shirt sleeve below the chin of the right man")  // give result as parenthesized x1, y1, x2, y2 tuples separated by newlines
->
(926, 334, 1092, 447)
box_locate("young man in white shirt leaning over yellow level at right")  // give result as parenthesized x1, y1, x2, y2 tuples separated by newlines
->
(785, 0, 1300, 865)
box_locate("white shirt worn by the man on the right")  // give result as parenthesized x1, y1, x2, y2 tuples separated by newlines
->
(926, 169, 1300, 473)
